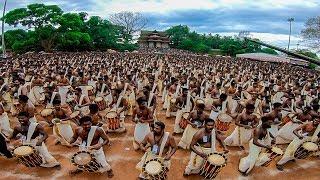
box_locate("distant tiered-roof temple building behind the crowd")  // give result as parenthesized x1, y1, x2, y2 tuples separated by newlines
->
(138, 30, 170, 48)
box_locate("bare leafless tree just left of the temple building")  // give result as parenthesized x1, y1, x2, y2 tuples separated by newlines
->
(110, 11, 148, 38)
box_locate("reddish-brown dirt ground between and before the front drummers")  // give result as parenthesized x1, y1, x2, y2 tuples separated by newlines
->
(0, 104, 320, 180)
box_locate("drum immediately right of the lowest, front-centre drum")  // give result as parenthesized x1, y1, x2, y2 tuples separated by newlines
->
(200, 153, 227, 179)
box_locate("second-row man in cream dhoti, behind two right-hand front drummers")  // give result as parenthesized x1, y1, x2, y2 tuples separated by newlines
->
(224, 104, 259, 149)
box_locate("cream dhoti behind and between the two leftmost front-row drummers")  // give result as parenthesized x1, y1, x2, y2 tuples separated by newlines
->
(53, 121, 76, 145)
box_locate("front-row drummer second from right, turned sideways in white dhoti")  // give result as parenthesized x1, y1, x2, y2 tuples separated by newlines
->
(239, 117, 273, 176)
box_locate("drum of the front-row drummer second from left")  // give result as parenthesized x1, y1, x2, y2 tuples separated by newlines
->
(71, 151, 101, 172)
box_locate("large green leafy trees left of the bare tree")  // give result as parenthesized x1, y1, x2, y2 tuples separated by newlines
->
(4, 4, 137, 53)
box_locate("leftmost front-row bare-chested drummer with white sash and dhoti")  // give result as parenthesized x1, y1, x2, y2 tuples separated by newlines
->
(11, 112, 60, 167)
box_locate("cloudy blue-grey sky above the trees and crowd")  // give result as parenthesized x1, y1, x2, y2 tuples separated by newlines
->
(1, 0, 320, 48)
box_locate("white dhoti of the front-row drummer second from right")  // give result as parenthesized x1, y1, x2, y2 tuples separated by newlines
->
(239, 135, 271, 174)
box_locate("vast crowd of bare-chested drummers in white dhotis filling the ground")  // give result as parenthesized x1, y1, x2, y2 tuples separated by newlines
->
(0, 50, 320, 179)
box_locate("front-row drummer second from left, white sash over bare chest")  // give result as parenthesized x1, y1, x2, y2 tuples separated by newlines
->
(69, 116, 113, 178)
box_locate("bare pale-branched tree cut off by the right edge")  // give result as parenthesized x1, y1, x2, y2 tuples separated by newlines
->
(301, 16, 320, 52)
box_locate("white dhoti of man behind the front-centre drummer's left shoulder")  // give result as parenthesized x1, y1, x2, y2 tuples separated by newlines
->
(133, 122, 151, 150)
